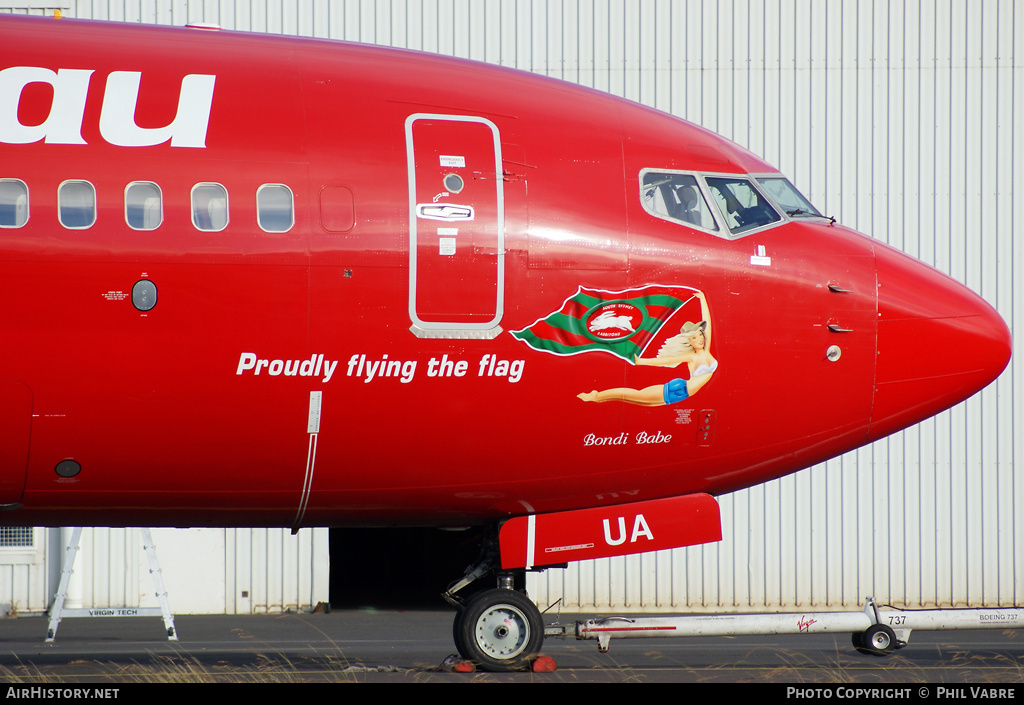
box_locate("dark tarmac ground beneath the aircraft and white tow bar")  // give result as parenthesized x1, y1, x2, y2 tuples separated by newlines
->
(0, 610, 1024, 684)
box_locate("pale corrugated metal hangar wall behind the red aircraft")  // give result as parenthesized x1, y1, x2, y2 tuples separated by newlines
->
(0, 0, 1024, 612)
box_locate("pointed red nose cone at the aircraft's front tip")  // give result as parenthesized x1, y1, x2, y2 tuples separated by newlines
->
(869, 246, 1013, 441)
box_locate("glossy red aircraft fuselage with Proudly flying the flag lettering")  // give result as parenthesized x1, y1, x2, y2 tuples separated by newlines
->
(0, 18, 1011, 545)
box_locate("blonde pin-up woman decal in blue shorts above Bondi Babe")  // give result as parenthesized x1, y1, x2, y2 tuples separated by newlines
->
(578, 291, 718, 407)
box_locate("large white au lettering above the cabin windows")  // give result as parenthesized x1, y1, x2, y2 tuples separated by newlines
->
(0, 67, 217, 148)
